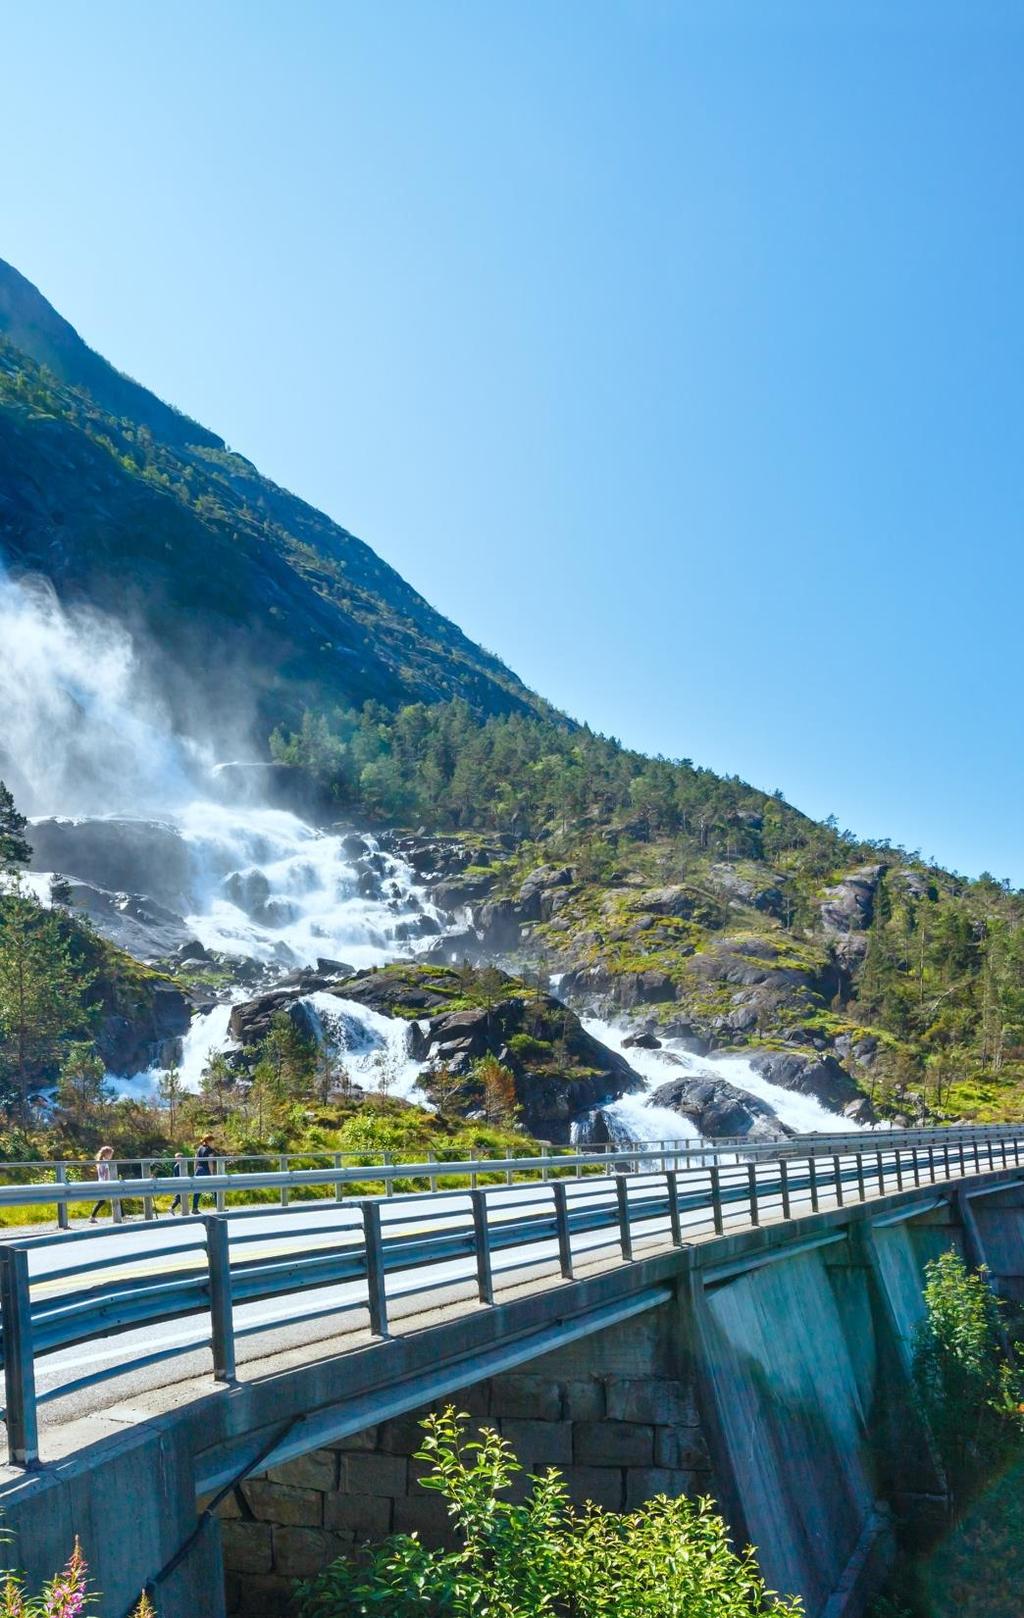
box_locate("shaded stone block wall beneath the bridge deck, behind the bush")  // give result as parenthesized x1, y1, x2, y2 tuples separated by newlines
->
(222, 1311, 713, 1618)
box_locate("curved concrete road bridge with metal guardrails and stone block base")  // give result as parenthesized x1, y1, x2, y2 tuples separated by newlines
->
(0, 1128, 1024, 1618)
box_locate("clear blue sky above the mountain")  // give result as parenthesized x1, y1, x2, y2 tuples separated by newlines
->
(0, 0, 1024, 883)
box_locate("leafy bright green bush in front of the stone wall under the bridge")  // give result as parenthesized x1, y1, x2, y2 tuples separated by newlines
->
(298, 1406, 801, 1618)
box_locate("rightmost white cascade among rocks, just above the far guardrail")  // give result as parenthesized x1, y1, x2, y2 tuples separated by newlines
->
(584, 1018, 862, 1141)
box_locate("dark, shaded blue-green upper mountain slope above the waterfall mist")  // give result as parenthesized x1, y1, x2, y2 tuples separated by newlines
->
(0, 260, 544, 726)
